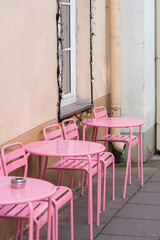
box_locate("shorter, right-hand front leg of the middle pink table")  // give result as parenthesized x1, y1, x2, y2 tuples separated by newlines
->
(97, 153, 101, 227)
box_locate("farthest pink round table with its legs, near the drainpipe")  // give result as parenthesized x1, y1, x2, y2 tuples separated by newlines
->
(82, 117, 144, 198)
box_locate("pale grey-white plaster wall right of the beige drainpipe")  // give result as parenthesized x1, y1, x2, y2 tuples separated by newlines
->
(120, 0, 155, 160)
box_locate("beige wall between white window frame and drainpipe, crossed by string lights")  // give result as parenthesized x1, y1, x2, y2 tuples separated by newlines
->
(77, 0, 110, 100)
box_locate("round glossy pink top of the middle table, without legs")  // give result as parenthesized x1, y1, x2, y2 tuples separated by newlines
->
(24, 140, 105, 157)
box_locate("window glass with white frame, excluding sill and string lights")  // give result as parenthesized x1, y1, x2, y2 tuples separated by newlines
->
(60, 0, 76, 107)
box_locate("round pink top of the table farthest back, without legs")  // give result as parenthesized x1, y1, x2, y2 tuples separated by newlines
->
(82, 117, 144, 128)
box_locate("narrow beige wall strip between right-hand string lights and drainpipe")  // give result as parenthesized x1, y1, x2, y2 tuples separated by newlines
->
(93, 0, 110, 100)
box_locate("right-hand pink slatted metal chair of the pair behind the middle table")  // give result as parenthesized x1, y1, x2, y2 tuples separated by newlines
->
(62, 118, 115, 210)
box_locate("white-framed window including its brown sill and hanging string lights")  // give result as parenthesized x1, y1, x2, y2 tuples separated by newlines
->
(56, 0, 94, 122)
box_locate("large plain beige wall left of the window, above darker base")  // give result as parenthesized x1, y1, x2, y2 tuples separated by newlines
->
(0, 0, 57, 143)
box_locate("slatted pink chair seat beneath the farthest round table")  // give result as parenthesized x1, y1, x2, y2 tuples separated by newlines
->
(96, 134, 139, 147)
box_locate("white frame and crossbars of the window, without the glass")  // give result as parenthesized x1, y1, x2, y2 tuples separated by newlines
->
(60, 0, 77, 107)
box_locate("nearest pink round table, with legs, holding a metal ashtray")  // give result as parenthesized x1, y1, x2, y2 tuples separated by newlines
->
(0, 176, 56, 240)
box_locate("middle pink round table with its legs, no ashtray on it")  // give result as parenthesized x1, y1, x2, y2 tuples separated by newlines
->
(25, 140, 105, 240)
